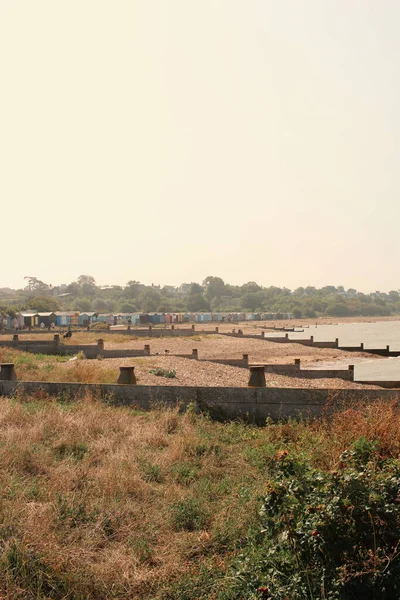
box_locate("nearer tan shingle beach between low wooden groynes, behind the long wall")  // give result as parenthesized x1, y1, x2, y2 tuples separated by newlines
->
(51, 336, 386, 389)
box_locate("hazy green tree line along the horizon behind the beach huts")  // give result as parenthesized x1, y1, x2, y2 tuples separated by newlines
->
(0, 275, 400, 318)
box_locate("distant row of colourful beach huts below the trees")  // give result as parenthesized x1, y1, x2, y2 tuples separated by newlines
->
(0, 311, 293, 329)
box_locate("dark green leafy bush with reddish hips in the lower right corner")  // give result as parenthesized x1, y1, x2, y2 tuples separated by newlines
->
(234, 438, 400, 600)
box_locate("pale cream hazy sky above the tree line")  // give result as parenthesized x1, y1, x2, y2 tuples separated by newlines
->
(0, 0, 400, 291)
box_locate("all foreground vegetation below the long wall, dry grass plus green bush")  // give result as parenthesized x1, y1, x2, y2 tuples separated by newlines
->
(0, 396, 400, 600)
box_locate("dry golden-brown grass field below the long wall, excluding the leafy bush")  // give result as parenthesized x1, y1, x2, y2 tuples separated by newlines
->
(0, 396, 400, 600)
